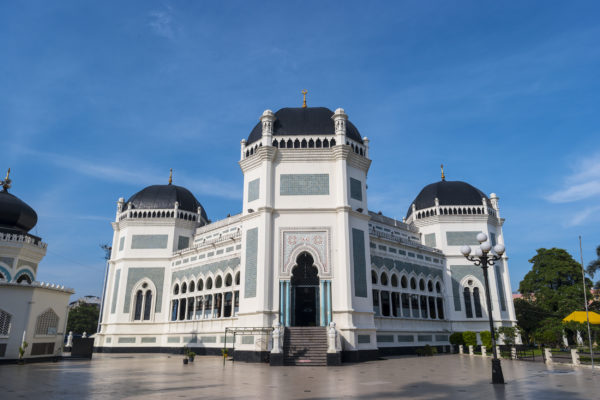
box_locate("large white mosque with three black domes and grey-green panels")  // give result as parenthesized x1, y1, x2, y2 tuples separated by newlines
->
(95, 104, 516, 364)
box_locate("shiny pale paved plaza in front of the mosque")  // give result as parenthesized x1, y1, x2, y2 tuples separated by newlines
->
(0, 354, 600, 400)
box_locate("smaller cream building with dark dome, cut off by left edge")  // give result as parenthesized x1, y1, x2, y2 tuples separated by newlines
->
(0, 169, 74, 362)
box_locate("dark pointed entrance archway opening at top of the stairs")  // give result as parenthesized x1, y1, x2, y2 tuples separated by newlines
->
(290, 252, 319, 326)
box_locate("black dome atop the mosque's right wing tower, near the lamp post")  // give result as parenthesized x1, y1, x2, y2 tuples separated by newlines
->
(406, 180, 491, 218)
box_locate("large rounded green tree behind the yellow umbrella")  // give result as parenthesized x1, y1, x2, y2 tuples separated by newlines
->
(519, 248, 592, 319)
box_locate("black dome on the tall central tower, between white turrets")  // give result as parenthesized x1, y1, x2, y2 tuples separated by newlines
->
(247, 107, 363, 144)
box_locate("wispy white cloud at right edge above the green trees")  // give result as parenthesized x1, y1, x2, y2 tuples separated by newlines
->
(546, 153, 600, 203)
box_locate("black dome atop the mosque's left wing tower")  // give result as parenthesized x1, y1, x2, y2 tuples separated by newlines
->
(126, 185, 208, 221)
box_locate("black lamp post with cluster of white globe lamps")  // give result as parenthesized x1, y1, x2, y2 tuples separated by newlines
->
(460, 232, 505, 384)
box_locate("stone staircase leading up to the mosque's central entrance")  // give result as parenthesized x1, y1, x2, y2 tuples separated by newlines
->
(283, 326, 327, 366)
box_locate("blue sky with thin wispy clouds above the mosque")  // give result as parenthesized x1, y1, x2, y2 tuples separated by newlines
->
(0, 0, 600, 298)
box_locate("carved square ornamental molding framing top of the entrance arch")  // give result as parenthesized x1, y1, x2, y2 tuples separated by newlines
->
(279, 227, 332, 279)
